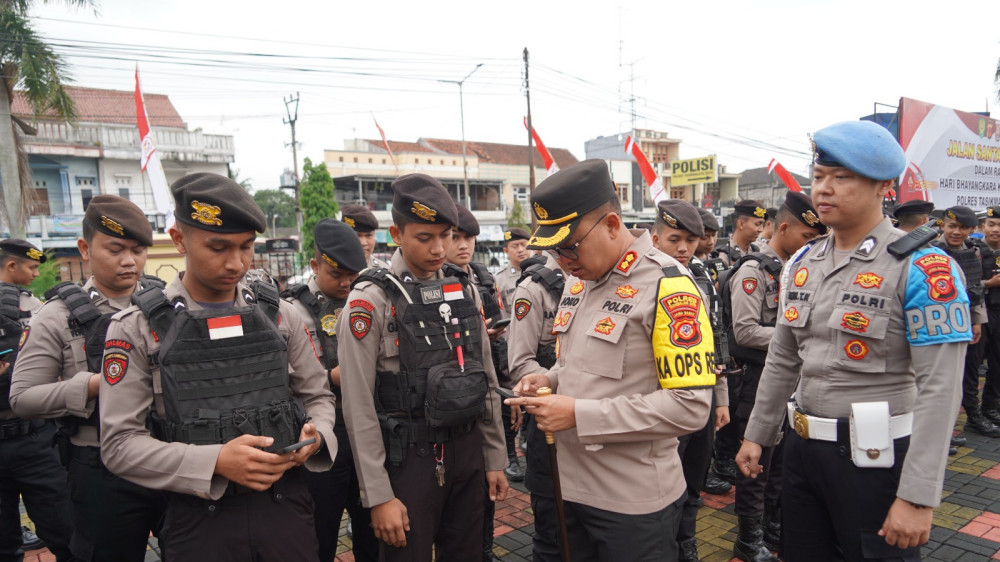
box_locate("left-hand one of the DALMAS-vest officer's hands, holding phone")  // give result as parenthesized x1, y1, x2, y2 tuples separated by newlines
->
(215, 435, 295, 492)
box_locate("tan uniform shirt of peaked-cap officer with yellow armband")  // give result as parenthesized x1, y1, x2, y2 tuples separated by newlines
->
(546, 231, 714, 515)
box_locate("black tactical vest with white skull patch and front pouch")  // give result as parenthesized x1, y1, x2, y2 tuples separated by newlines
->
(355, 264, 489, 464)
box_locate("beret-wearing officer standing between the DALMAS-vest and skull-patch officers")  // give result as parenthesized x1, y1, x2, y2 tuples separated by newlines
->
(282, 218, 378, 562)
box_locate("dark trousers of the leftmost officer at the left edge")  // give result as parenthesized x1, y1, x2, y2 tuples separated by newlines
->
(0, 421, 73, 562)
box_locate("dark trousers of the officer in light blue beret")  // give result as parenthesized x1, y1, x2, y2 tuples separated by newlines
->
(781, 421, 920, 562)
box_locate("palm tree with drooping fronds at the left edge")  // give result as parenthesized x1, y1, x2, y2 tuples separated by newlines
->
(0, 0, 96, 237)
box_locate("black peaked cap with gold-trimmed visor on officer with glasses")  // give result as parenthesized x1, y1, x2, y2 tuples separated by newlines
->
(528, 159, 616, 246)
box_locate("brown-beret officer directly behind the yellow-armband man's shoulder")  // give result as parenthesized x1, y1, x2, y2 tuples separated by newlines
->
(652, 199, 730, 562)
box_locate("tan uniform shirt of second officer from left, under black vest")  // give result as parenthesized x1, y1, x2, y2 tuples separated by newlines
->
(10, 277, 129, 447)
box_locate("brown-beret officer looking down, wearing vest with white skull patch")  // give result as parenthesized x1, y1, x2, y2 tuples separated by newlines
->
(337, 174, 507, 561)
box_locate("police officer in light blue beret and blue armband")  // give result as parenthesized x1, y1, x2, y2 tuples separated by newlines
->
(737, 121, 972, 562)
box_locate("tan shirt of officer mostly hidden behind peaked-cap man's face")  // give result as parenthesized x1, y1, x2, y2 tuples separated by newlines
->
(507, 252, 583, 383)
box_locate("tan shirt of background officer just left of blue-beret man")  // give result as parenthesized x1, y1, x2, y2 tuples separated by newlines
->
(729, 245, 784, 351)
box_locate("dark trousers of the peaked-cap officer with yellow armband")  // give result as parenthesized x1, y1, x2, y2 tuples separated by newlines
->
(564, 495, 684, 562)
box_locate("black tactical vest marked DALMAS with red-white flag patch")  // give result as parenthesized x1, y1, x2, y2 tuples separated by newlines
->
(132, 283, 305, 452)
